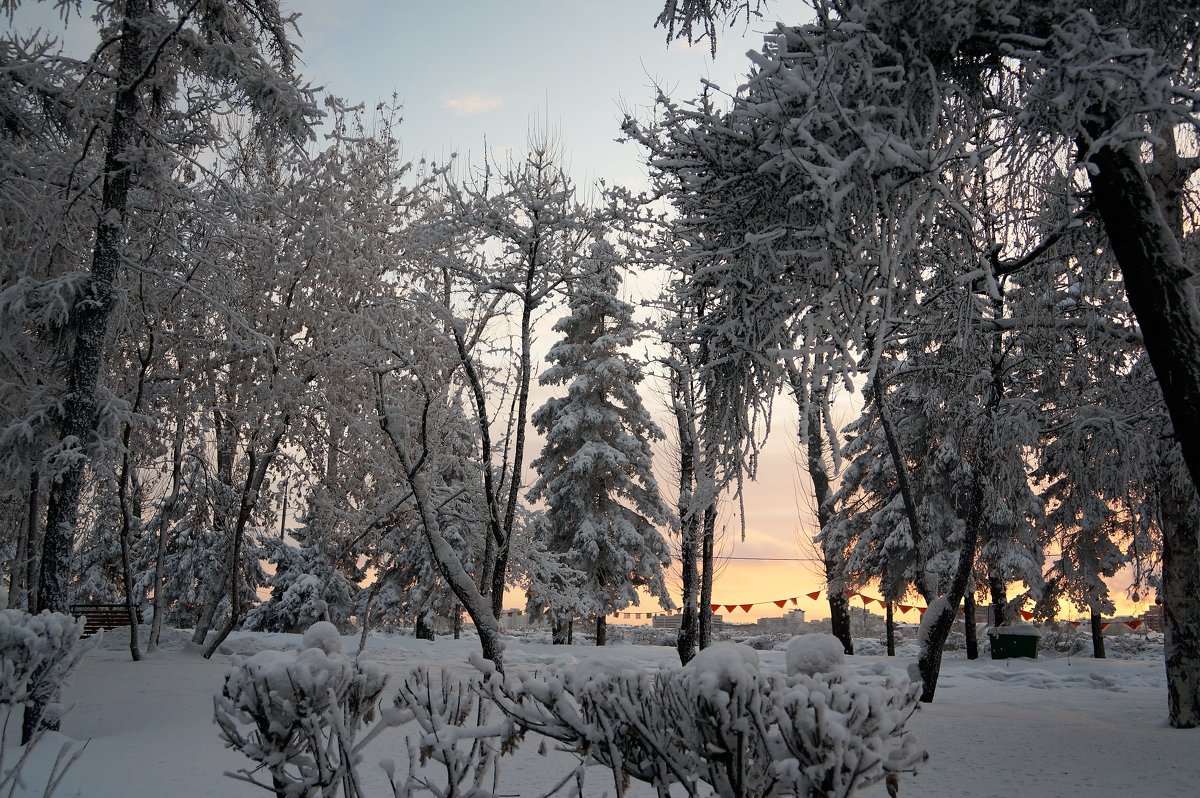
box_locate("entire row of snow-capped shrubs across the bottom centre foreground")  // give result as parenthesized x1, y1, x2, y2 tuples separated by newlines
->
(217, 624, 925, 798)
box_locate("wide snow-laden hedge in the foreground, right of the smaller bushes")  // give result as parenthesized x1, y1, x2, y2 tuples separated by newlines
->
(482, 643, 925, 797)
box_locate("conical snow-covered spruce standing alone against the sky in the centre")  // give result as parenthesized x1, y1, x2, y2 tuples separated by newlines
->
(529, 242, 670, 644)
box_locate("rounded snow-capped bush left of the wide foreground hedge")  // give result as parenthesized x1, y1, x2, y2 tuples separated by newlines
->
(215, 622, 388, 798)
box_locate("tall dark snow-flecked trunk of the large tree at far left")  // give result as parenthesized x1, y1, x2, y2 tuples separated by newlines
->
(36, 0, 148, 612)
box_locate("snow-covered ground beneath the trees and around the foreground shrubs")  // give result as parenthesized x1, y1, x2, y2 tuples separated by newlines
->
(16, 630, 1200, 798)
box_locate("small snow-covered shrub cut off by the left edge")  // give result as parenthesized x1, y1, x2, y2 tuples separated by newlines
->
(0, 610, 95, 794)
